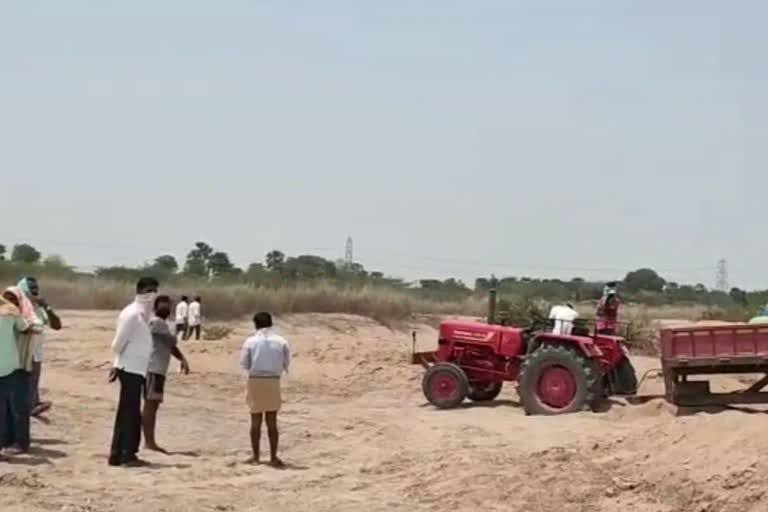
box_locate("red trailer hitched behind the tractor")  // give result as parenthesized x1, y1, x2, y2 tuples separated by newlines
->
(661, 324, 768, 406)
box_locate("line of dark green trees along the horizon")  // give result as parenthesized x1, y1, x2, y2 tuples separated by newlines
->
(0, 242, 768, 306)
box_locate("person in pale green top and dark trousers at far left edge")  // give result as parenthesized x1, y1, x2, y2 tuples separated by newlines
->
(0, 291, 29, 450)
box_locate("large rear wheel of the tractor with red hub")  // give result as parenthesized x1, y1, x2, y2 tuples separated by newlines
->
(518, 344, 600, 415)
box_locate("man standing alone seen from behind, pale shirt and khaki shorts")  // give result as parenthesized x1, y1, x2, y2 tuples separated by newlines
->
(240, 313, 291, 467)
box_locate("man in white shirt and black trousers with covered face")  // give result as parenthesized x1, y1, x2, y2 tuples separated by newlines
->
(108, 277, 159, 467)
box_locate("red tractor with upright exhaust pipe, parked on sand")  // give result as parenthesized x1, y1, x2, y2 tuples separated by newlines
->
(412, 296, 637, 415)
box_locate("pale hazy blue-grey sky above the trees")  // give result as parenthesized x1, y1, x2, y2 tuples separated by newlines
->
(0, 0, 768, 288)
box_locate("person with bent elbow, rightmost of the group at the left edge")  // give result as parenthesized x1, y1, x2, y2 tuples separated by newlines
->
(16, 277, 61, 416)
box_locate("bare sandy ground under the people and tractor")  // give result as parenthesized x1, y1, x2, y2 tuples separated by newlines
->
(0, 312, 768, 512)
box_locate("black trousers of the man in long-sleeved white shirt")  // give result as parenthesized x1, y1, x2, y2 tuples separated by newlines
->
(109, 370, 144, 463)
